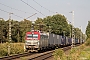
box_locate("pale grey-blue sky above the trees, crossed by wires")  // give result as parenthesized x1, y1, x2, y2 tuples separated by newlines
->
(0, 0, 90, 33)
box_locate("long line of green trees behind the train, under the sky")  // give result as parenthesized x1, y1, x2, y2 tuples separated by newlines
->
(0, 14, 85, 43)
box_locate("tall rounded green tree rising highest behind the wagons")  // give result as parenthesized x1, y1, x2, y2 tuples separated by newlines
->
(43, 14, 70, 36)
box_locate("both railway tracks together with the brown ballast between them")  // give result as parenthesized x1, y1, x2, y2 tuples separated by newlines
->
(0, 45, 79, 60)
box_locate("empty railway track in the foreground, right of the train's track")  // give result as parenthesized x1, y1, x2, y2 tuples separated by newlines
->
(28, 45, 79, 60)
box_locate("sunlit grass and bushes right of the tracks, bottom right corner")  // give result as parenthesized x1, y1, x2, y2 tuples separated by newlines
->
(53, 39, 90, 60)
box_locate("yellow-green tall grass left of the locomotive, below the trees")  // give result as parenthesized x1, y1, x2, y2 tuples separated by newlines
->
(0, 43, 24, 57)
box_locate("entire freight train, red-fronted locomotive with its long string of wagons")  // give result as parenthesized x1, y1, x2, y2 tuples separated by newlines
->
(25, 31, 81, 52)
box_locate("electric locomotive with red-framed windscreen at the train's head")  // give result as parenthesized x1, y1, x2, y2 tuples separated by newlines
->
(25, 31, 48, 52)
